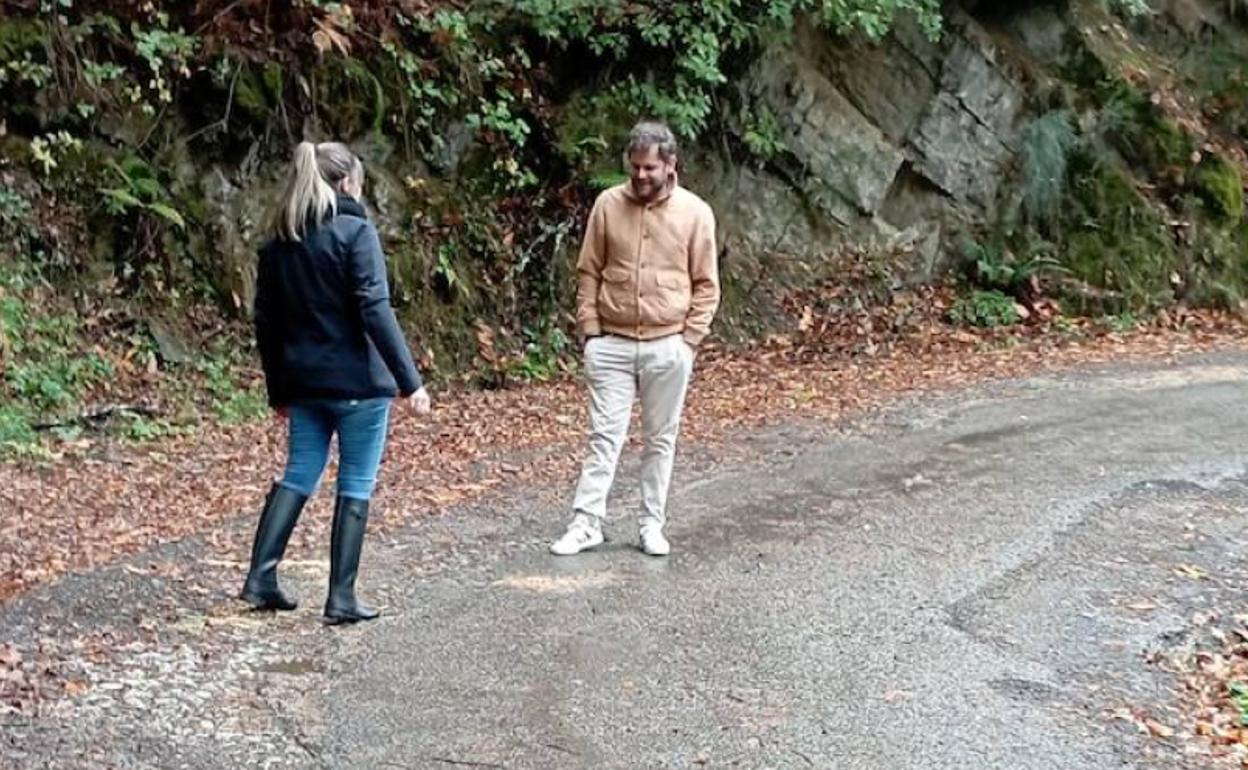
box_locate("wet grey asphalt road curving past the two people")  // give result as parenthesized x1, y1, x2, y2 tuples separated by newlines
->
(0, 354, 1248, 770)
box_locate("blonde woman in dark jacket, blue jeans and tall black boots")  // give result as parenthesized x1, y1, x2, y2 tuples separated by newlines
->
(242, 142, 429, 624)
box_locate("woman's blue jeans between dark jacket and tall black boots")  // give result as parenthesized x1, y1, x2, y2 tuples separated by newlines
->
(281, 398, 392, 500)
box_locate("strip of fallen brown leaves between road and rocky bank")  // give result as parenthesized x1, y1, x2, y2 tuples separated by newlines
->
(7, 286, 1248, 718)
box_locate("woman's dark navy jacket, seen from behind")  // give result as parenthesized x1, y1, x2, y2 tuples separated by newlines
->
(256, 196, 421, 407)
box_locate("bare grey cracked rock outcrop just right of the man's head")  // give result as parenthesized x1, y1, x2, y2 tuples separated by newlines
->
(693, 5, 1027, 275)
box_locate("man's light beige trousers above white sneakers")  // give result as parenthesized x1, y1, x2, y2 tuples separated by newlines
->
(573, 334, 694, 528)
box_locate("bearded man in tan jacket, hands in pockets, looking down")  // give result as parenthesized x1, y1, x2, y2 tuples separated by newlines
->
(550, 122, 719, 557)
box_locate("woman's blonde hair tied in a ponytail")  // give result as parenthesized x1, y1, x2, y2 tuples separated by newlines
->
(273, 142, 363, 241)
